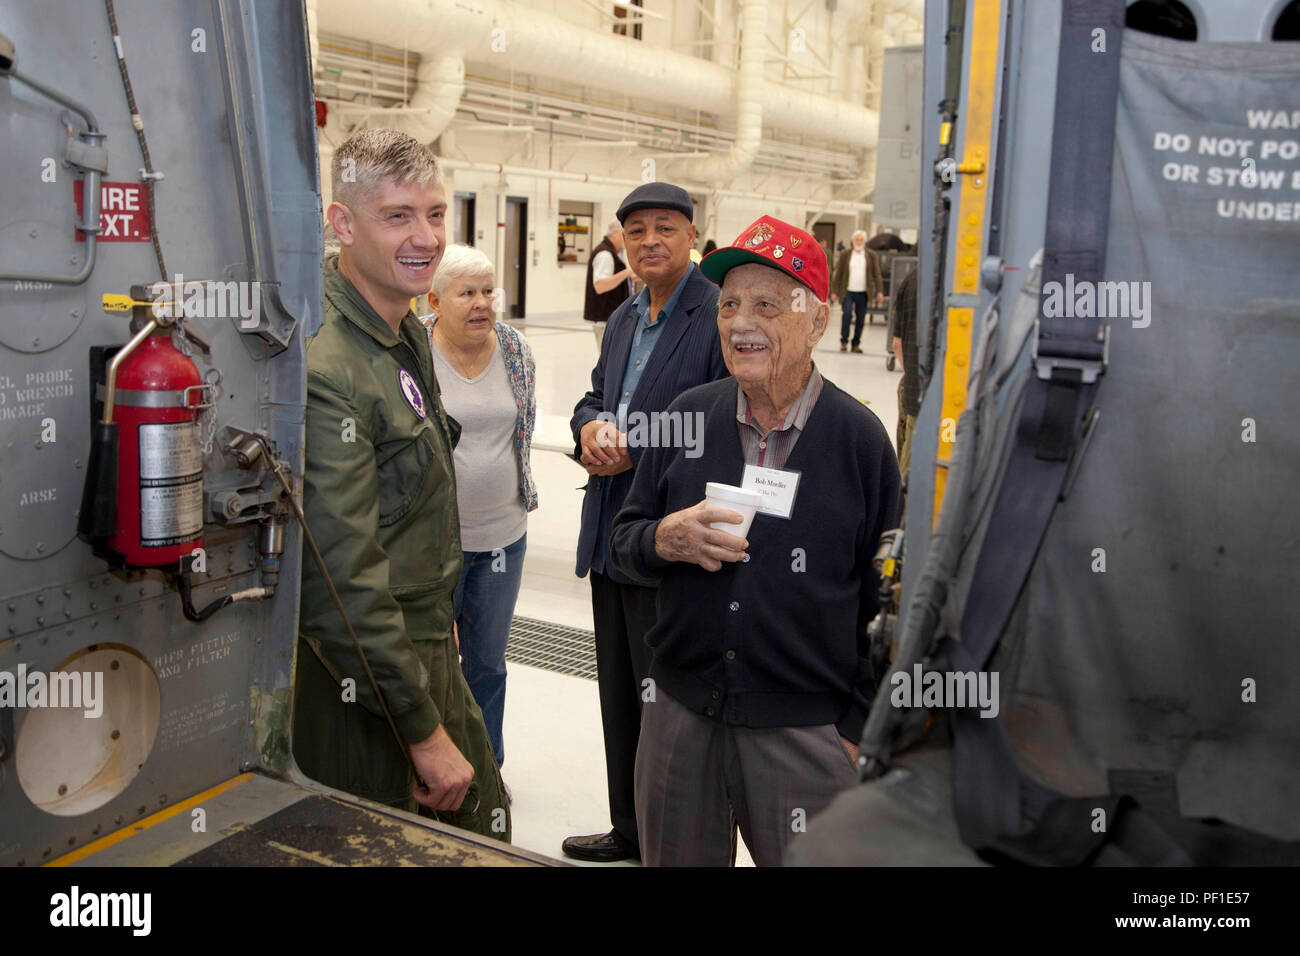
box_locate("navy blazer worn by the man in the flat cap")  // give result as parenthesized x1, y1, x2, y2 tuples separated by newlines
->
(569, 263, 727, 584)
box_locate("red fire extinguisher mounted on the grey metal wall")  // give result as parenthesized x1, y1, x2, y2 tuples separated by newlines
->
(104, 329, 207, 567)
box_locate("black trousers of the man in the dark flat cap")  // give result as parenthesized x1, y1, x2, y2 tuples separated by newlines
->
(590, 571, 657, 847)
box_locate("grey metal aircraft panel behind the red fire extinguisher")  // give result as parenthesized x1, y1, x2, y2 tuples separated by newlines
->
(0, 0, 314, 865)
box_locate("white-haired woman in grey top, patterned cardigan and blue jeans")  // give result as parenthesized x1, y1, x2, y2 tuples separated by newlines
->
(426, 246, 537, 765)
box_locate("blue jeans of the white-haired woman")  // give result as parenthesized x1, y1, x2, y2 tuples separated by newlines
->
(455, 533, 528, 766)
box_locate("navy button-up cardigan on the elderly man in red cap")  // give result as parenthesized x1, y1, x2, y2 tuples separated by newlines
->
(612, 377, 900, 741)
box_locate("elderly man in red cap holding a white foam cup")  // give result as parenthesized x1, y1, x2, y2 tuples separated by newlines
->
(611, 216, 900, 866)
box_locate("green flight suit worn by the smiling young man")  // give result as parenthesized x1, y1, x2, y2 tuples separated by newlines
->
(294, 256, 510, 843)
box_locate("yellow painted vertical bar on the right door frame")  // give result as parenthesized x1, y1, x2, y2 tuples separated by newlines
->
(933, 0, 1002, 524)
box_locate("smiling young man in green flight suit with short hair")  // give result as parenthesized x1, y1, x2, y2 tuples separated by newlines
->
(294, 129, 510, 842)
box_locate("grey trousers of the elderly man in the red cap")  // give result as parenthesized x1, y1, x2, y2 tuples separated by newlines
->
(636, 688, 857, 866)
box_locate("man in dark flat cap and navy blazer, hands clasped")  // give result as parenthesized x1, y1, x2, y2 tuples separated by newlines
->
(563, 182, 727, 862)
